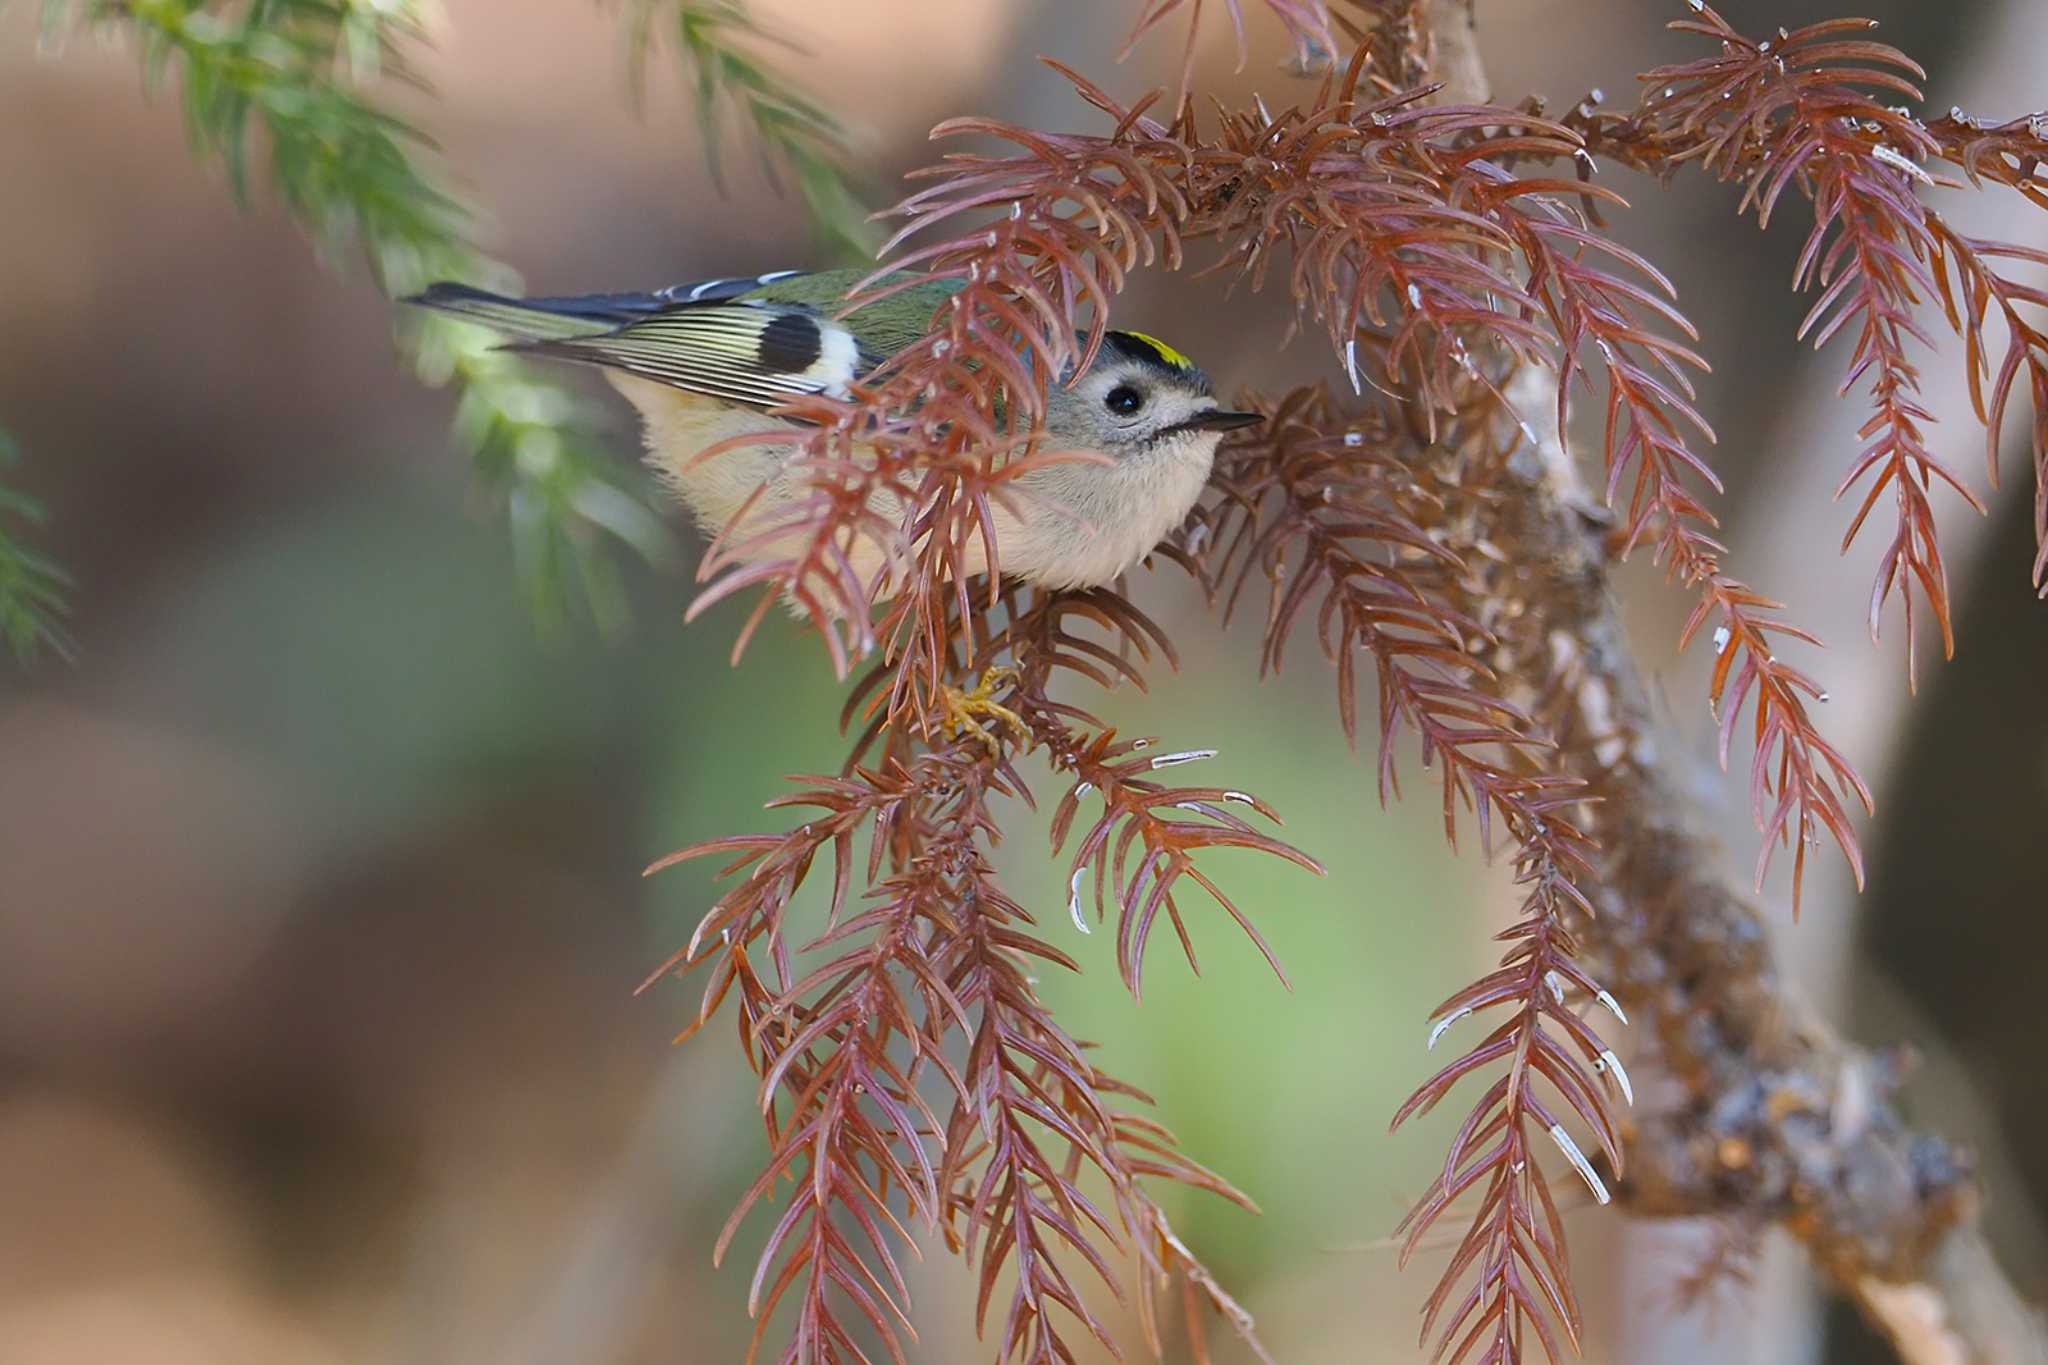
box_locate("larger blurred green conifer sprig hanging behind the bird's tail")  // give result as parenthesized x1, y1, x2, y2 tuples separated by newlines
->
(43, 0, 672, 628)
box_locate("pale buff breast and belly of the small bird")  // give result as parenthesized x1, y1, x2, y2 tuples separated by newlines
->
(606, 370, 1217, 596)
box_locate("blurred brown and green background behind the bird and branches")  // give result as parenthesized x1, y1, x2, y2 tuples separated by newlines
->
(0, 0, 2048, 1365)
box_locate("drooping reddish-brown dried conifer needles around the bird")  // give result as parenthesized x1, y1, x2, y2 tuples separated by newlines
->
(655, 0, 2048, 1363)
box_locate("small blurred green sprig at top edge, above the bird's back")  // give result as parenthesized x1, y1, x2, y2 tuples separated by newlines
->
(625, 0, 879, 262)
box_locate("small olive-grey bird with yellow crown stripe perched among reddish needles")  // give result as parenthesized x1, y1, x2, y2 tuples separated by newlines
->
(410, 270, 1260, 596)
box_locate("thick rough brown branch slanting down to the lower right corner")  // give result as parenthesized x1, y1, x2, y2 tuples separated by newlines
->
(1458, 370, 2048, 1365)
